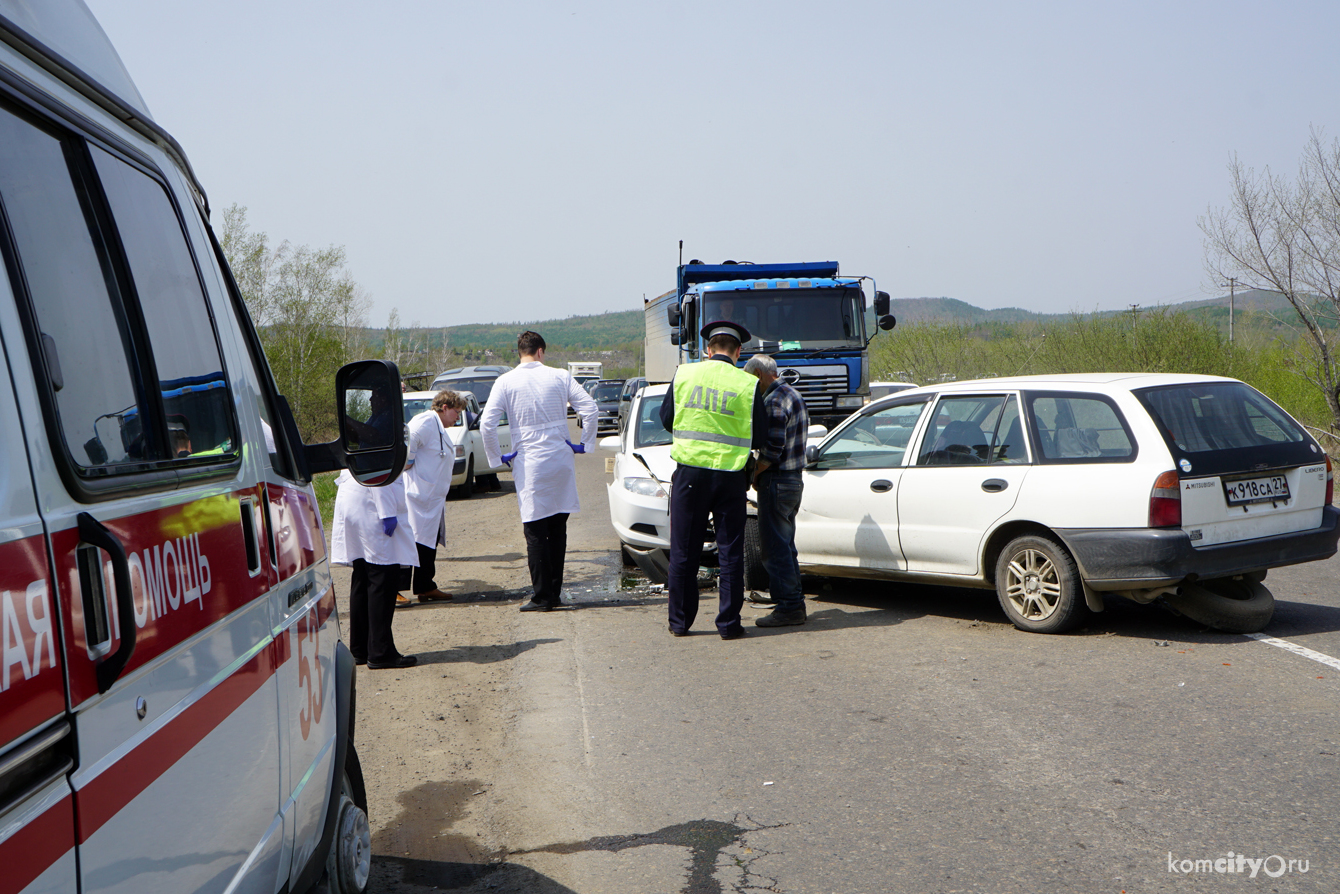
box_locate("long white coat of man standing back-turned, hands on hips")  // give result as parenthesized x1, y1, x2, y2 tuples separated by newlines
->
(480, 361, 599, 521)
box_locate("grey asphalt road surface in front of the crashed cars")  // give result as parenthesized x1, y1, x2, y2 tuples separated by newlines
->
(356, 428, 1340, 894)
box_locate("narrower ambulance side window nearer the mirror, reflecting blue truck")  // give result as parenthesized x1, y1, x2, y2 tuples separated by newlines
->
(91, 147, 236, 458)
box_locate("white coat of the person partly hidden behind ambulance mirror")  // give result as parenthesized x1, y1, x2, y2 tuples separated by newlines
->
(331, 469, 418, 567)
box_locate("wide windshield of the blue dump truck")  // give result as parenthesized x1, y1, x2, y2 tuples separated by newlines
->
(702, 288, 866, 351)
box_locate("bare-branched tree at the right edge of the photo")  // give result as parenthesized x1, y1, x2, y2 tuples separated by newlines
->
(1198, 131, 1340, 437)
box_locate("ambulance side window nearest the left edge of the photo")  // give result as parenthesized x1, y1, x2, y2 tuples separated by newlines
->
(0, 100, 158, 474)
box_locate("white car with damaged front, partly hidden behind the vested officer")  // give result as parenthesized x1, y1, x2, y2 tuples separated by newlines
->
(600, 385, 675, 583)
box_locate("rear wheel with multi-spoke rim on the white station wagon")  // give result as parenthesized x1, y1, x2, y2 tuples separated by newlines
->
(996, 535, 1089, 633)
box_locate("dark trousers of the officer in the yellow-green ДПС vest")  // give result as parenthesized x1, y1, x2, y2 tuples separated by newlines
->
(666, 465, 749, 634)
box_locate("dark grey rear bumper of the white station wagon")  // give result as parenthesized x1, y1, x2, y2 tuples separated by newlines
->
(1056, 505, 1340, 590)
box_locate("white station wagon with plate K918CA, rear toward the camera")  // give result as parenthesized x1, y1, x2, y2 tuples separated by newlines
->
(746, 373, 1340, 633)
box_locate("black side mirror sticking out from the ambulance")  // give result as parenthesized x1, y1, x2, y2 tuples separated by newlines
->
(303, 361, 406, 487)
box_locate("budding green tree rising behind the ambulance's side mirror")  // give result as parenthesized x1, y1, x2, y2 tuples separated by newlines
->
(220, 205, 370, 441)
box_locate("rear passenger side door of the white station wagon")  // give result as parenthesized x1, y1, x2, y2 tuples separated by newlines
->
(898, 393, 1030, 576)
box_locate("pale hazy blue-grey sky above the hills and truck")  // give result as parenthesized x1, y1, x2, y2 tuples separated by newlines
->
(86, 0, 1340, 327)
